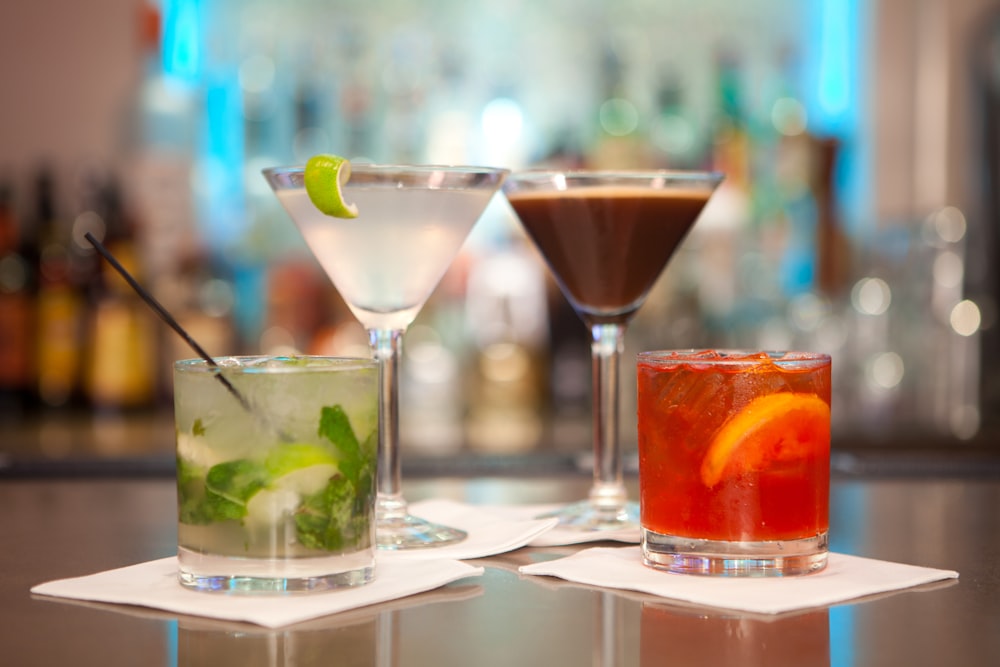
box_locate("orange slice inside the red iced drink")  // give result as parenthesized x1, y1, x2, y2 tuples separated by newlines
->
(701, 392, 830, 487)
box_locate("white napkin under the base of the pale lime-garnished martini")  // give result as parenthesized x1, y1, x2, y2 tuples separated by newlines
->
(378, 500, 557, 561)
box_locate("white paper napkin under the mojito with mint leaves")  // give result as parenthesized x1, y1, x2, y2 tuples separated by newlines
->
(31, 556, 484, 628)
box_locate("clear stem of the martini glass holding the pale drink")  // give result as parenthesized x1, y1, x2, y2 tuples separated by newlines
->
(368, 329, 406, 516)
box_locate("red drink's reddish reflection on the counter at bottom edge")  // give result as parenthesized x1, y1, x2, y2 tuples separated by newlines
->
(639, 603, 830, 667)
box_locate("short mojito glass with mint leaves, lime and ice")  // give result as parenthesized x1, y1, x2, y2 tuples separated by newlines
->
(174, 357, 378, 592)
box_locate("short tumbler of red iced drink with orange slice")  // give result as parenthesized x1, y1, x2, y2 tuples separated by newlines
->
(637, 350, 830, 576)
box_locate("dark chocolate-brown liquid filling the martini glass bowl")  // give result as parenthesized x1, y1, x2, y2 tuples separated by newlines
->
(508, 186, 711, 323)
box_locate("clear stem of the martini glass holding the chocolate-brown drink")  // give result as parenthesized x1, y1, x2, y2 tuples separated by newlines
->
(590, 324, 626, 511)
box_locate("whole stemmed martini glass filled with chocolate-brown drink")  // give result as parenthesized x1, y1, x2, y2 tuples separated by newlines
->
(503, 170, 723, 531)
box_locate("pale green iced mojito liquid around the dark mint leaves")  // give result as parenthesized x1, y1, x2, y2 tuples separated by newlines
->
(174, 358, 378, 575)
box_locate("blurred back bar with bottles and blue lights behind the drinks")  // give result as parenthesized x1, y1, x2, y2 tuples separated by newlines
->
(0, 0, 1000, 472)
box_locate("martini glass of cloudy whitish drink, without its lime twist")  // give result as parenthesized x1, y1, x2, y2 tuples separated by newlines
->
(264, 165, 508, 549)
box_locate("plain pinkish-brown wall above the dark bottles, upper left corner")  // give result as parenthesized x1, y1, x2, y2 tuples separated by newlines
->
(0, 0, 141, 197)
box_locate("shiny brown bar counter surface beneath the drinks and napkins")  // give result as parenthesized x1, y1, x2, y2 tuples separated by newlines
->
(0, 457, 1000, 667)
